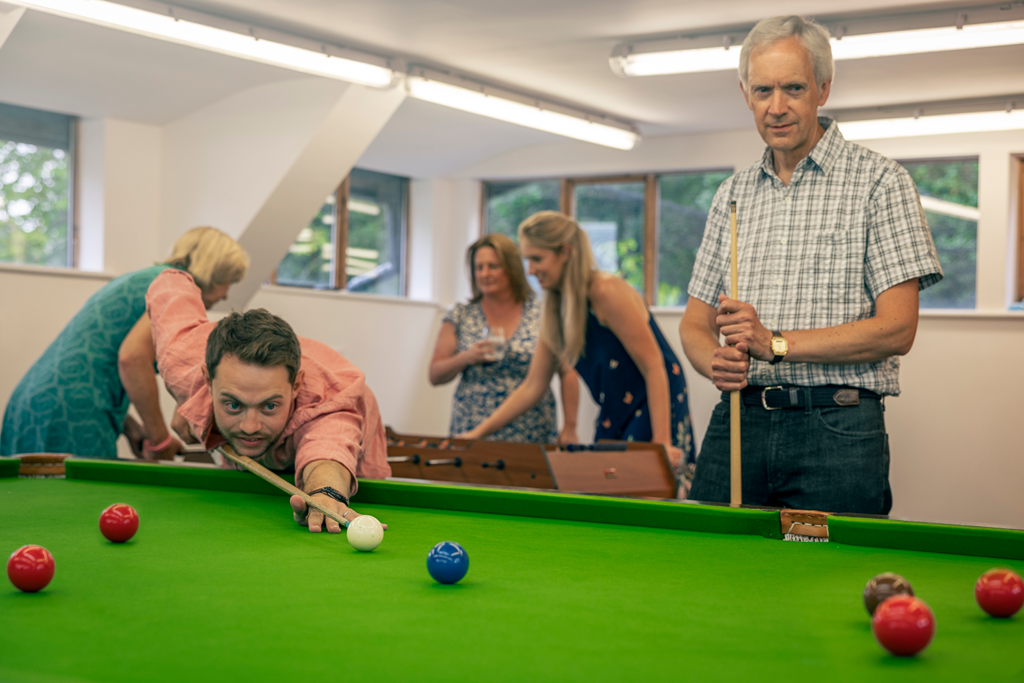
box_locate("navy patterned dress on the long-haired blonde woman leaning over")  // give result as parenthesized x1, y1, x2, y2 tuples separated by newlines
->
(575, 310, 696, 498)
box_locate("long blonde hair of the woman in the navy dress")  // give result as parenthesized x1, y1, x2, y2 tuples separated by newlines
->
(519, 211, 597, 366)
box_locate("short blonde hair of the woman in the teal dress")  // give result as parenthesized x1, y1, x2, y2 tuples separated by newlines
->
(164, 227, 249, 292)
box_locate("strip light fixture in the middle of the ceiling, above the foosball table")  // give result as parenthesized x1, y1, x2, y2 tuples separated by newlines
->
(406, 69, 640, 150)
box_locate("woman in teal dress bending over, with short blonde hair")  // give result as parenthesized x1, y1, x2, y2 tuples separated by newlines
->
(0, 227, 249, 458)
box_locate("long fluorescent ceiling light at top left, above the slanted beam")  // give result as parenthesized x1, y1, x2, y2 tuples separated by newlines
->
(12, 0, 394, 88)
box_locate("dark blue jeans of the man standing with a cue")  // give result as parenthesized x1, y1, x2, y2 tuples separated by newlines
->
(689, 394, 892, 515)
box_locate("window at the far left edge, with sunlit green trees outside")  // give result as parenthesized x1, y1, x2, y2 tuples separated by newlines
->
(0, 104, 75, 267)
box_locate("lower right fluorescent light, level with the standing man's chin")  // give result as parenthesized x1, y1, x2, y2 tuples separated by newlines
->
(839, 110, 1024, 140)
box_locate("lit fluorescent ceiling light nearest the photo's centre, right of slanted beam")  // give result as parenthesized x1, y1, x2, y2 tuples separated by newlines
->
(406, 76, 639, 150)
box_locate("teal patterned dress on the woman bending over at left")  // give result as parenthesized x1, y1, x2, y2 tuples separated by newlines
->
(0, 265, 169, 458)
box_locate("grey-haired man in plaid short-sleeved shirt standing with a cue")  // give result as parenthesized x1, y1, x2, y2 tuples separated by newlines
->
(680, 16, 942, 514)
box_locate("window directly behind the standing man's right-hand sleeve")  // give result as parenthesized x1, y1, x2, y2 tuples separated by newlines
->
(901, 159, 979, 308)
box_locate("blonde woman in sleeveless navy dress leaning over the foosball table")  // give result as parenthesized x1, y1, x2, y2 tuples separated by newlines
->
(461, 211, 695, 497)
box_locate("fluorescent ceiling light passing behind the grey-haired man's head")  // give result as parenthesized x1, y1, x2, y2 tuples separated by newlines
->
(608, 17, 1024, 76)
